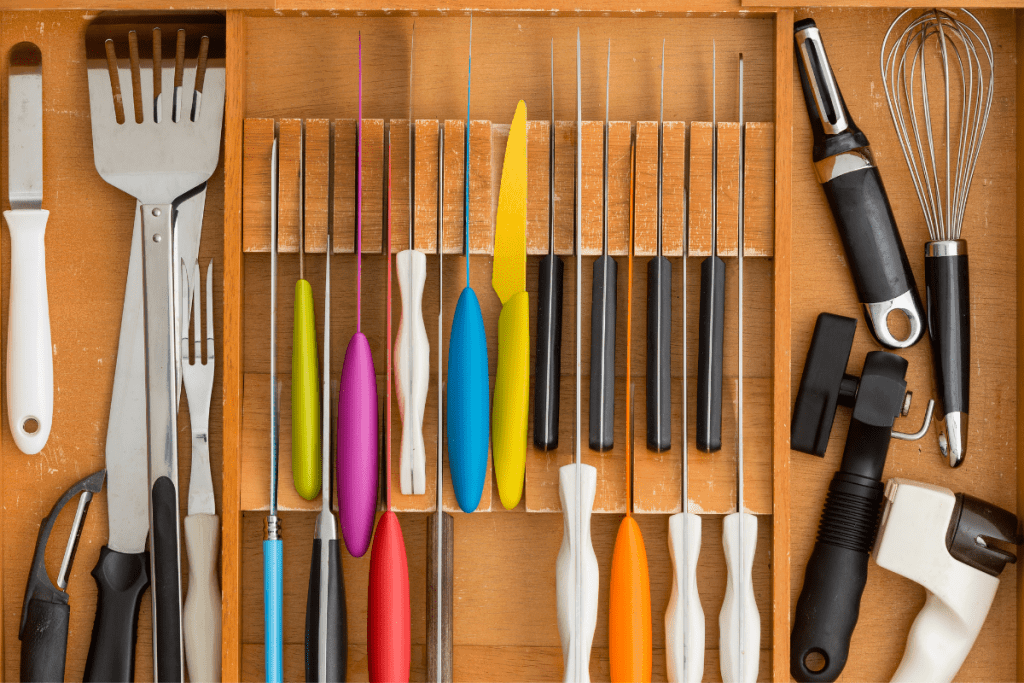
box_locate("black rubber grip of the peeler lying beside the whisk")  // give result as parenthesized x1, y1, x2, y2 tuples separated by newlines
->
(822, 167, 922, 310)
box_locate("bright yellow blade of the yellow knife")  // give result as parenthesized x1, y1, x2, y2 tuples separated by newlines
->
(490, 99, 526, 304)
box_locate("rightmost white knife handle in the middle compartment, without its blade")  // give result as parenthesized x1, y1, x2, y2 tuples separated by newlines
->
(718, 512, 761, 683)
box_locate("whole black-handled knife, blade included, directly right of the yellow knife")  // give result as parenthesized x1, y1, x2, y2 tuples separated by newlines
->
(534, 39, 565, 451)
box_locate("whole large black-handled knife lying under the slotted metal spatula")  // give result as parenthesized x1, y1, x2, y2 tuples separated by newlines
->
(84, 186, 206, 683)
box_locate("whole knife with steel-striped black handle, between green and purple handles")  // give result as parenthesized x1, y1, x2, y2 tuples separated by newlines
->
(305, 123, 348, 683)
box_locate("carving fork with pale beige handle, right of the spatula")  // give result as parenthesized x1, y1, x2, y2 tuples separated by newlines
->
(180, 261, 221, 683)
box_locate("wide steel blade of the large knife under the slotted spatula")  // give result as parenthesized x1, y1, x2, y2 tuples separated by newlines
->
(106, 187, 206, 554)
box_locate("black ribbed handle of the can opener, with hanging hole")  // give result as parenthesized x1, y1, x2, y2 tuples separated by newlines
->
(790, 472, 883, 683)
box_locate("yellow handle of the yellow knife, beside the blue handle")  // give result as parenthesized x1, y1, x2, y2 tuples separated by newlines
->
(492, 292, 529, 510)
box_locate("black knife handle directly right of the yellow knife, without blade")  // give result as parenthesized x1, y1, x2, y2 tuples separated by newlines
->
(534, 254, 565, 451)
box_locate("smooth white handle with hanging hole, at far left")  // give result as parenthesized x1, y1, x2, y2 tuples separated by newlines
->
(3, 209, 53, 456)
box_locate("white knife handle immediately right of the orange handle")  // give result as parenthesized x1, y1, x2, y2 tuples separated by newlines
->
(665, 512, 705, 683)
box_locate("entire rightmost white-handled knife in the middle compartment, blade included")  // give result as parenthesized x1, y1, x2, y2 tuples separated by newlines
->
(718, 53, 761, 683)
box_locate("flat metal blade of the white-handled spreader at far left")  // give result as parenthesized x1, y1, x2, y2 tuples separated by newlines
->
(7, 43, 43, 211)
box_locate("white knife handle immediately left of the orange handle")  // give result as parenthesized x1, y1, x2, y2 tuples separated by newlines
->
(555, 465, 600, 683)
